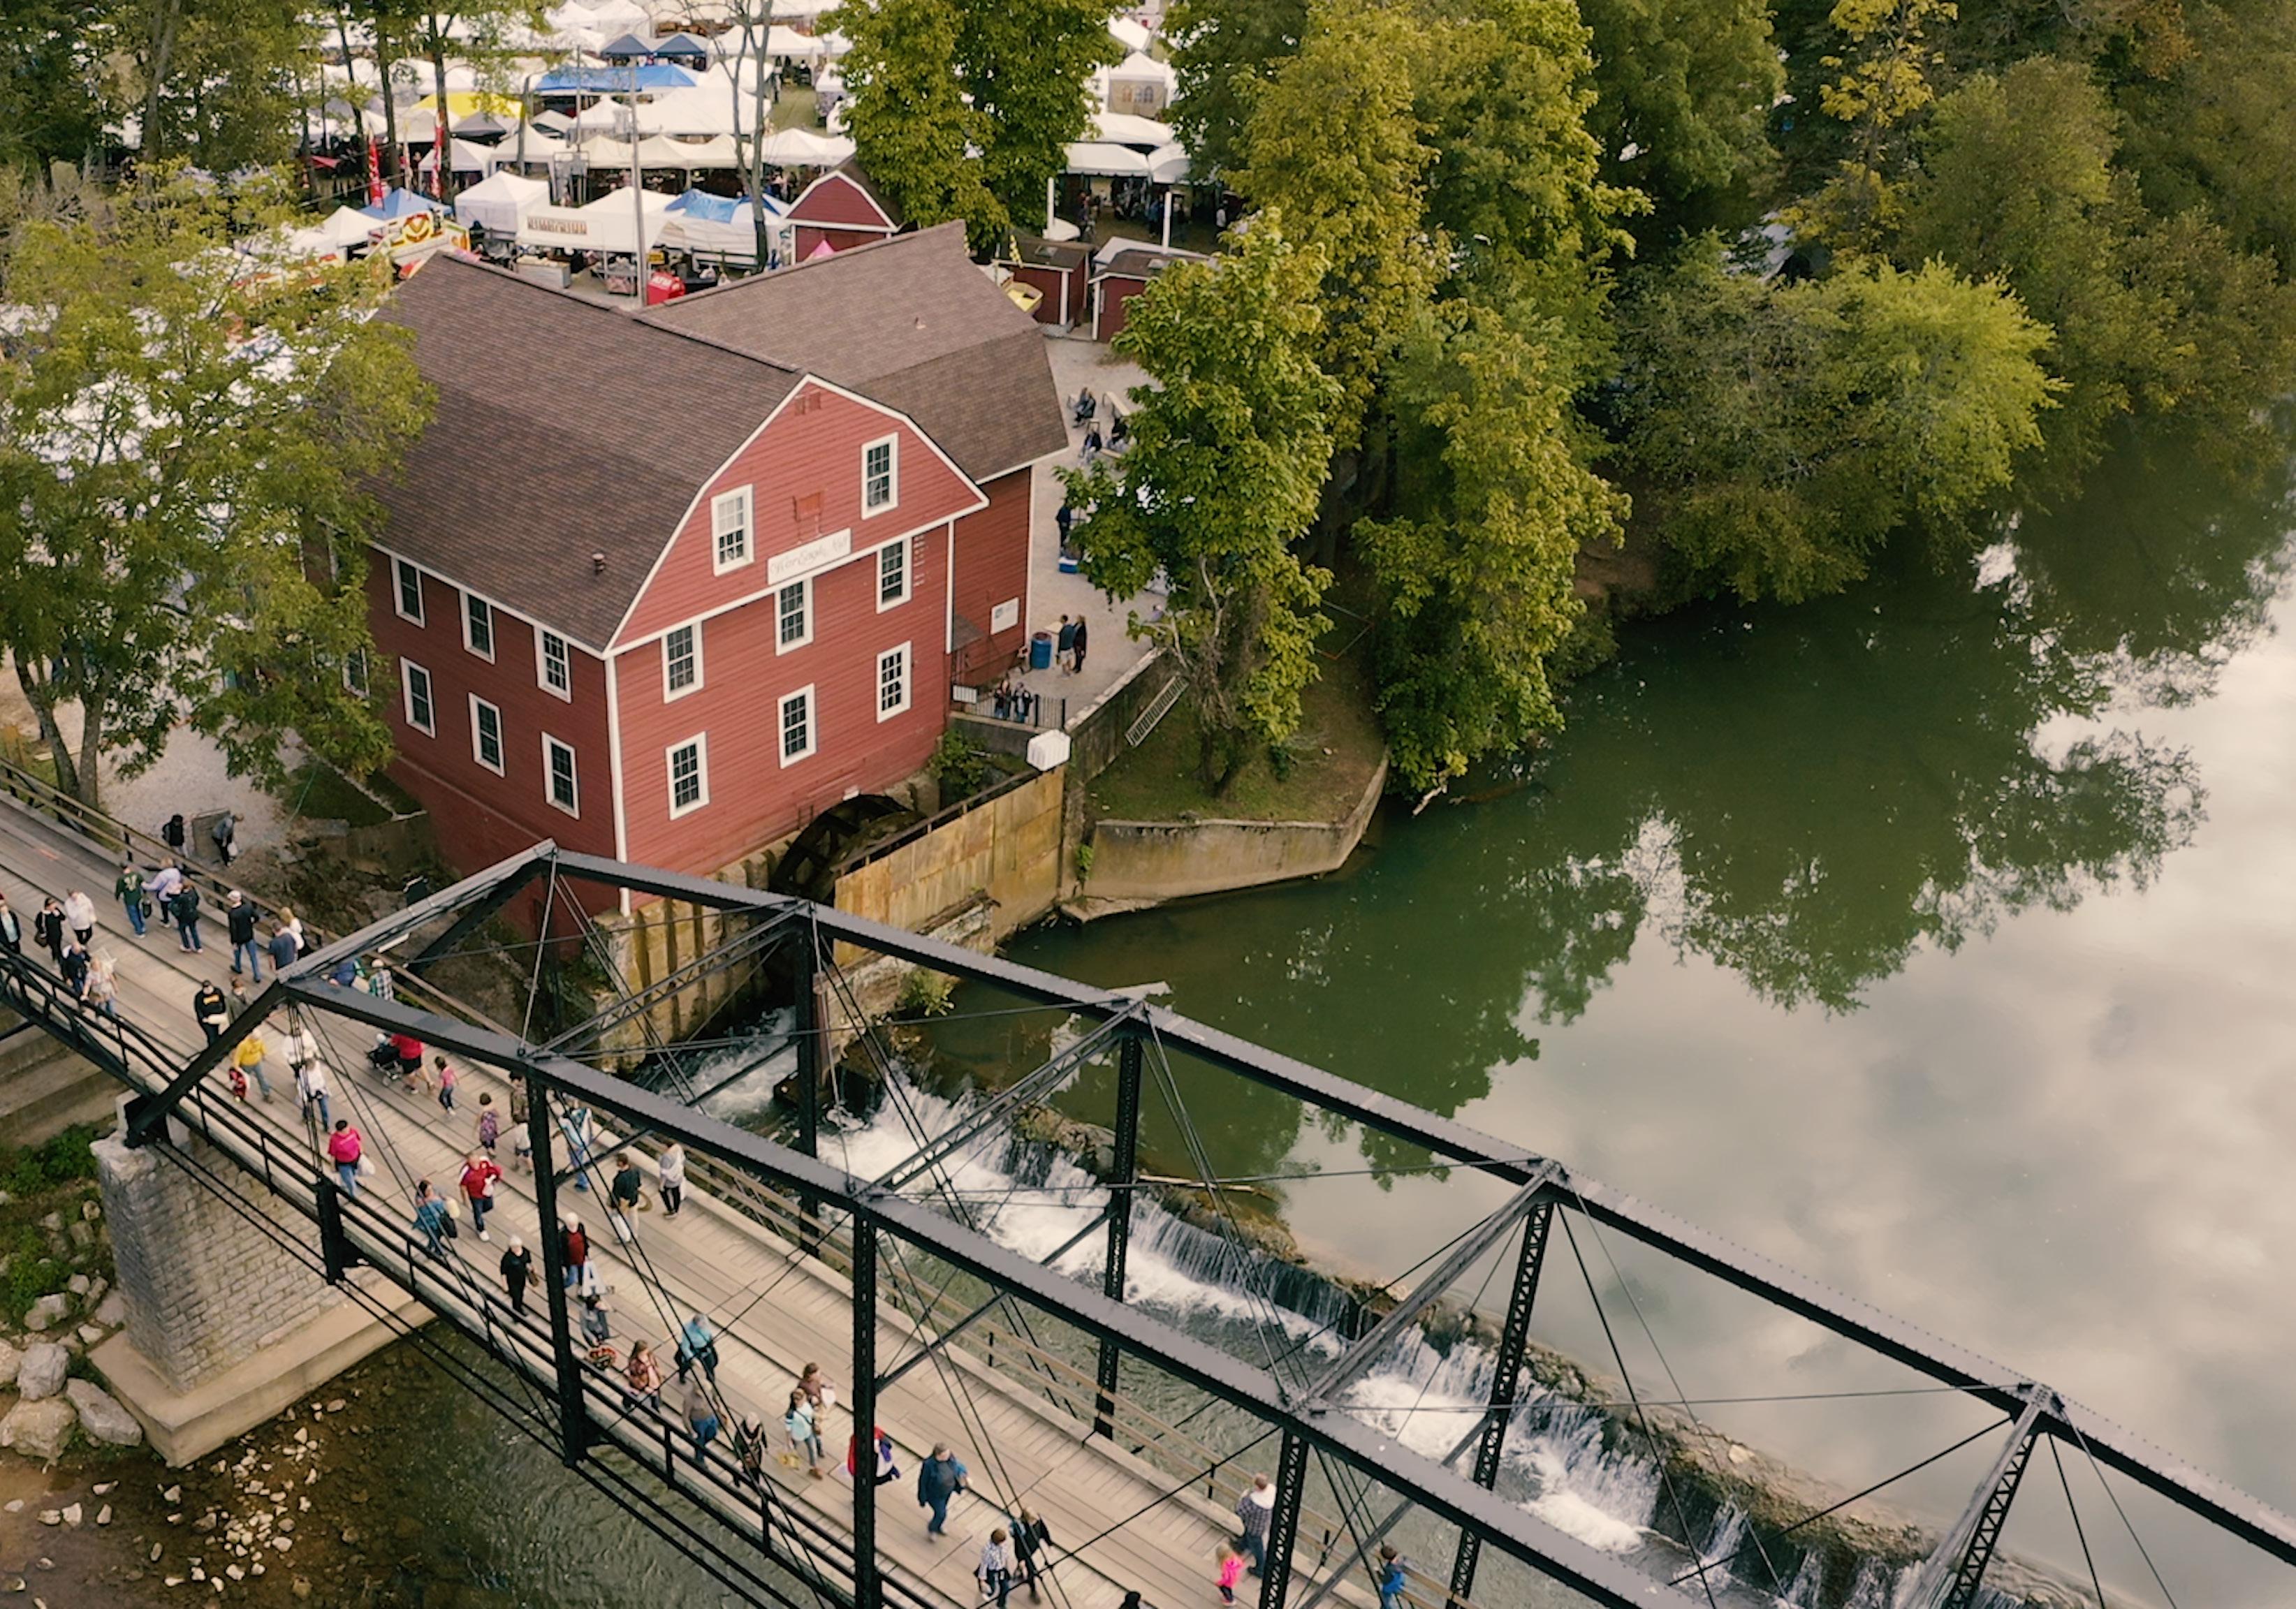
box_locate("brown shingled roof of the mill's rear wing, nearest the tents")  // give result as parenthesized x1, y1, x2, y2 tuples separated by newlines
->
(645, 223, 1067, 480)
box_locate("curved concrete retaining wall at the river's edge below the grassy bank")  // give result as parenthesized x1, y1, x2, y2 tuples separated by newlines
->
(1081, 760, 1387, 902)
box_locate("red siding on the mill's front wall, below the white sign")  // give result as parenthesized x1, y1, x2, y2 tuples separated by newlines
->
(615, 518, 949, 872)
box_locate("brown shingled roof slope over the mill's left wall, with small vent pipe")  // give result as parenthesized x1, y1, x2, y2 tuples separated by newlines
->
(379, 253, 801, 649)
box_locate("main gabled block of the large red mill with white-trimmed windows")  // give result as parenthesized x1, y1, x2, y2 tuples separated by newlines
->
(370, 254, 1058, 925)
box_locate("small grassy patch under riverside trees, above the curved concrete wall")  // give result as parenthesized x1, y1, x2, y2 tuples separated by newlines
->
(1090, 652, 1384, 822)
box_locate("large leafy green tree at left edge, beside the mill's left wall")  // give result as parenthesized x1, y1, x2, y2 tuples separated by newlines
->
(0, 184, 427, 803)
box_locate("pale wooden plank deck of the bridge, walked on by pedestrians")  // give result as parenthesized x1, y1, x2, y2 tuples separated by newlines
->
(0, 799, 1370, 1609)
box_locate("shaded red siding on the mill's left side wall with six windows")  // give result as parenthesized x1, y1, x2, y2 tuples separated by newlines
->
(367, 553, 615, 932)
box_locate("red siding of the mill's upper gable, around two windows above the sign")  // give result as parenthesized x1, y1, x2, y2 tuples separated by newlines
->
(615, 381, 981, 654)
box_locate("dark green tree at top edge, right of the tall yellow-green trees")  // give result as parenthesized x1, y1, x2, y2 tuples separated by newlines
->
(1579, 0, 1786, 205)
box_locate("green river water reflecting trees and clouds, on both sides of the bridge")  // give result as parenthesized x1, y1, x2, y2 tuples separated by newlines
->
(328, 429, 2296, 1604)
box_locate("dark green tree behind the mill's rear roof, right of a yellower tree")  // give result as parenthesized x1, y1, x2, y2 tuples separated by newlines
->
(955, 0, 1123, 232)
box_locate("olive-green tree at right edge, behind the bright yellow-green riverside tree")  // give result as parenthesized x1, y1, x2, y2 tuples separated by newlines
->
(1894, 57, 2296, 491)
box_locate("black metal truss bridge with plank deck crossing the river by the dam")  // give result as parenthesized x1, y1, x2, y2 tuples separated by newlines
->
(0, 806, 2296, 1609)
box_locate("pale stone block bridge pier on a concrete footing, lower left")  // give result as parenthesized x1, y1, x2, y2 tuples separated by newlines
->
(89, 1122, 427, 1464)
